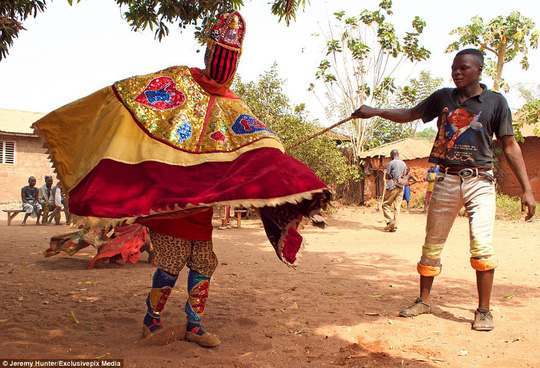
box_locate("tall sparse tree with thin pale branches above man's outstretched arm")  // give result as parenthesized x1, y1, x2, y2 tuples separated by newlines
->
(310, 0, 430, 157)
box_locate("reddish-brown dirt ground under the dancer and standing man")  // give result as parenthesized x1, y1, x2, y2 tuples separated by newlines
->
(0, 207, 540, 368)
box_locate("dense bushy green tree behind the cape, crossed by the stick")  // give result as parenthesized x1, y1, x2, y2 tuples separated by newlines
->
(232, 63, 351, 184)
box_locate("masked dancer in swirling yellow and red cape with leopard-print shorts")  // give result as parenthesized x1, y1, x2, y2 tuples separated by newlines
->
(34, 11, 330, 346)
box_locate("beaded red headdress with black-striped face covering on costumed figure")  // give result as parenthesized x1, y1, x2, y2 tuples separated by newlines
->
(204, 10, 246, 86)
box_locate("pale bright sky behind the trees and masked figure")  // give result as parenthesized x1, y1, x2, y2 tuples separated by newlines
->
(0, 0, 540, 125)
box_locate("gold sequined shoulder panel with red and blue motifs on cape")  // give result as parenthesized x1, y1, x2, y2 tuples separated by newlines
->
(114, 66, 279, 153)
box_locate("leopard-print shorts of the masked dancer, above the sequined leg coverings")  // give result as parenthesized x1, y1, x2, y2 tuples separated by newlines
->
(150, 231, 218, 278)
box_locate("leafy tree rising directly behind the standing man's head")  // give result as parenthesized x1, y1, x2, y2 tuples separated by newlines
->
(445, 11, 539, 92)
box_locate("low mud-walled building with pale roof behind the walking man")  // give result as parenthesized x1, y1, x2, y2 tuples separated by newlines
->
(359, 138, 433, 203)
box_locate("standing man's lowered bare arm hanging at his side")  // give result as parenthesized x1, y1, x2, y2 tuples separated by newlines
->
(499, 135, 536, 220)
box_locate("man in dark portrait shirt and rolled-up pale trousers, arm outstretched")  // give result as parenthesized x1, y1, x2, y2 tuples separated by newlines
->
(352, 49, 536, 331)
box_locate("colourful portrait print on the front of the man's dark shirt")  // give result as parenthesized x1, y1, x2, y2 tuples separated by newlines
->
(431, 107, 483, 164)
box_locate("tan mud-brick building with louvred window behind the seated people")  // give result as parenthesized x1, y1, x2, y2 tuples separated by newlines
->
(0, 109, 56, 202)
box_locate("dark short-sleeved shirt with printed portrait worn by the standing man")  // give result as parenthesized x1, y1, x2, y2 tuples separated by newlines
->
(416, 84, 514, 167)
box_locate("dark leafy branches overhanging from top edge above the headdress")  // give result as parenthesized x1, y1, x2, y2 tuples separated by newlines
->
(0, 0, 306, 61)
